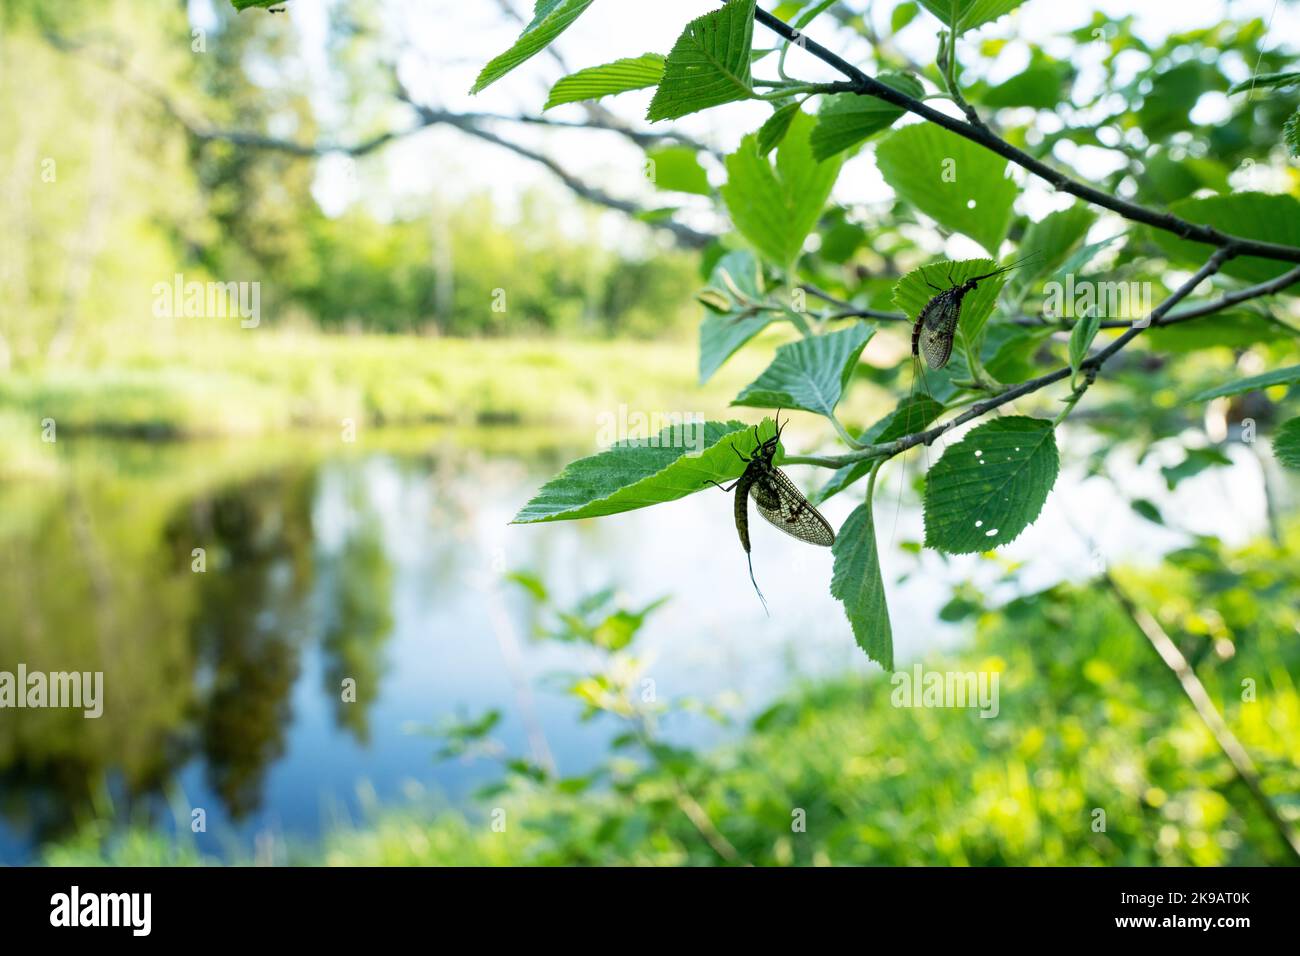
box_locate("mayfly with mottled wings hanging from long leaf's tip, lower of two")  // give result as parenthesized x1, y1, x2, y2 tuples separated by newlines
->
(705, 411, 835, 611)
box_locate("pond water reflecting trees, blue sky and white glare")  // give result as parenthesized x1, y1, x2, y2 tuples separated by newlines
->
(0, 428, 1264, 864)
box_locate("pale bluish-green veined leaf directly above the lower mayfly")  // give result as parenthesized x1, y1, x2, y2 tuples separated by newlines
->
(732, 323, 875, 418)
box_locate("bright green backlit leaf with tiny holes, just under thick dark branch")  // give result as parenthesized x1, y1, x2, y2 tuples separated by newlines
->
(876, 122, 1018, 255)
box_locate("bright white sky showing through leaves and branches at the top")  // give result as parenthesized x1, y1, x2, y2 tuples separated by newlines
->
(258, 0, 1300, 254)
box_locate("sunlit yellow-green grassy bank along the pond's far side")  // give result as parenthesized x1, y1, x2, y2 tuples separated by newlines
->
(0, 330, 764, 438)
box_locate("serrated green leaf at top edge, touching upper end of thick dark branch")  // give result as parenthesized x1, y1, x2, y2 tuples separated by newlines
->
(646, 0, 754, 122)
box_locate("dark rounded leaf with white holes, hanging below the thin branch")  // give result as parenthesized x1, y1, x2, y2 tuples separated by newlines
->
(926, 416, 1060, 554)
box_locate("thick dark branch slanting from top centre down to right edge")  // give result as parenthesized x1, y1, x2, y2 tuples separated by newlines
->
(754, 8, 1300, 263)
